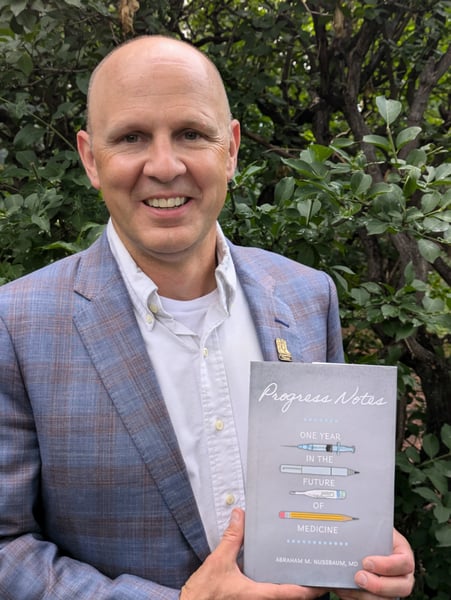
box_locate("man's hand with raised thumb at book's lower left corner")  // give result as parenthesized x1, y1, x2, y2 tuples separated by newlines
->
(180, 509, 325, 600)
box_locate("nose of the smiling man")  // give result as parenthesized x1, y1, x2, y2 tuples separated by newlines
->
(143, 137, 186, 183)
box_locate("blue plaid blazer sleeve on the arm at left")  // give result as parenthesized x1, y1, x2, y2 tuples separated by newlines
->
(0, 318, 179, 600)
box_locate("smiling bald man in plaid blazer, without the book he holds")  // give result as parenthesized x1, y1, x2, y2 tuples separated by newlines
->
(0, 36, 413, 600)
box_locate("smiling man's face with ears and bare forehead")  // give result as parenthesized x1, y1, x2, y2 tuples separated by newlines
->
(78, 43, 239, 271)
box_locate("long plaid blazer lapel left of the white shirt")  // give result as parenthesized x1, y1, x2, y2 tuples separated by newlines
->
(74, 235, 209, 560)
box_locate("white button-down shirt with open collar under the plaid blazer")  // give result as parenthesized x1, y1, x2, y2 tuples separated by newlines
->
(107, 222, 262, 549)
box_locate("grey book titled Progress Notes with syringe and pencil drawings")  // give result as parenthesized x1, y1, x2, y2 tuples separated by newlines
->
(244, 362, 397, 588)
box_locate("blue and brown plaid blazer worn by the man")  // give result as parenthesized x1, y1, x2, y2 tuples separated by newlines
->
(0, 235, 343, 600)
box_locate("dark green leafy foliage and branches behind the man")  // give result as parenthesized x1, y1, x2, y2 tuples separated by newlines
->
(0, 0, 451, 600)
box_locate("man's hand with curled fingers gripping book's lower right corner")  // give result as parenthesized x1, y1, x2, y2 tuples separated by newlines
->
(335, 529, 415, 600)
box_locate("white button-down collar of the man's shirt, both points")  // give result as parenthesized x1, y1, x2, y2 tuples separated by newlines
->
(106, 219, 237, 319)
